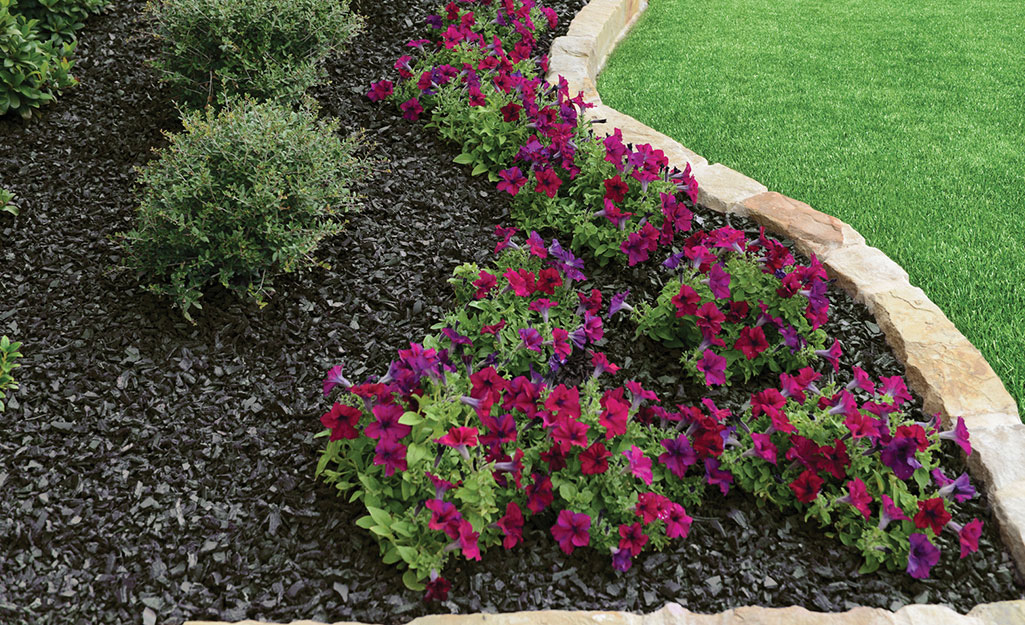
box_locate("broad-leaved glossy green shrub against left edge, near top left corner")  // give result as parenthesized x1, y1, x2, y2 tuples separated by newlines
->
(0, 0, 78, 118)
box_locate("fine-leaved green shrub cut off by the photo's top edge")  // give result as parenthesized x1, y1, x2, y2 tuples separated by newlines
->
(148, 0, 363, 106)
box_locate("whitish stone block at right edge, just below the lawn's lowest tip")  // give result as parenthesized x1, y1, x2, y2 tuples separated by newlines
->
(968, 423, 1025, 493)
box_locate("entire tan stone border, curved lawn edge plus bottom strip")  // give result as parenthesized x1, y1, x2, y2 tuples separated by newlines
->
(186, 0, 1025, 625)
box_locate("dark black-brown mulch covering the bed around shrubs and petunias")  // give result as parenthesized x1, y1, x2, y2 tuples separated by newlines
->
(0, 0, 1023, 625)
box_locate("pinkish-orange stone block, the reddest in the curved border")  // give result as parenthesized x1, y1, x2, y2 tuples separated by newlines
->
(743, 192, 865, 257)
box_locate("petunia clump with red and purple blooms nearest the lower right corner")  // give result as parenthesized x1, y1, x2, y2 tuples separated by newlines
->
(724, 367, 982, 578)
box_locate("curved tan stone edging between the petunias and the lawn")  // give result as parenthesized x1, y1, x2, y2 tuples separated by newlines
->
(548, 0, 1025, 602)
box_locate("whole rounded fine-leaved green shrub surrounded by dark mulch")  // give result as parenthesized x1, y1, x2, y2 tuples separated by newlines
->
(122, 98, 373, 319)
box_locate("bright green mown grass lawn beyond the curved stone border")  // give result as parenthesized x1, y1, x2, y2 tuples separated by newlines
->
(599, 0, 1025, 415)
